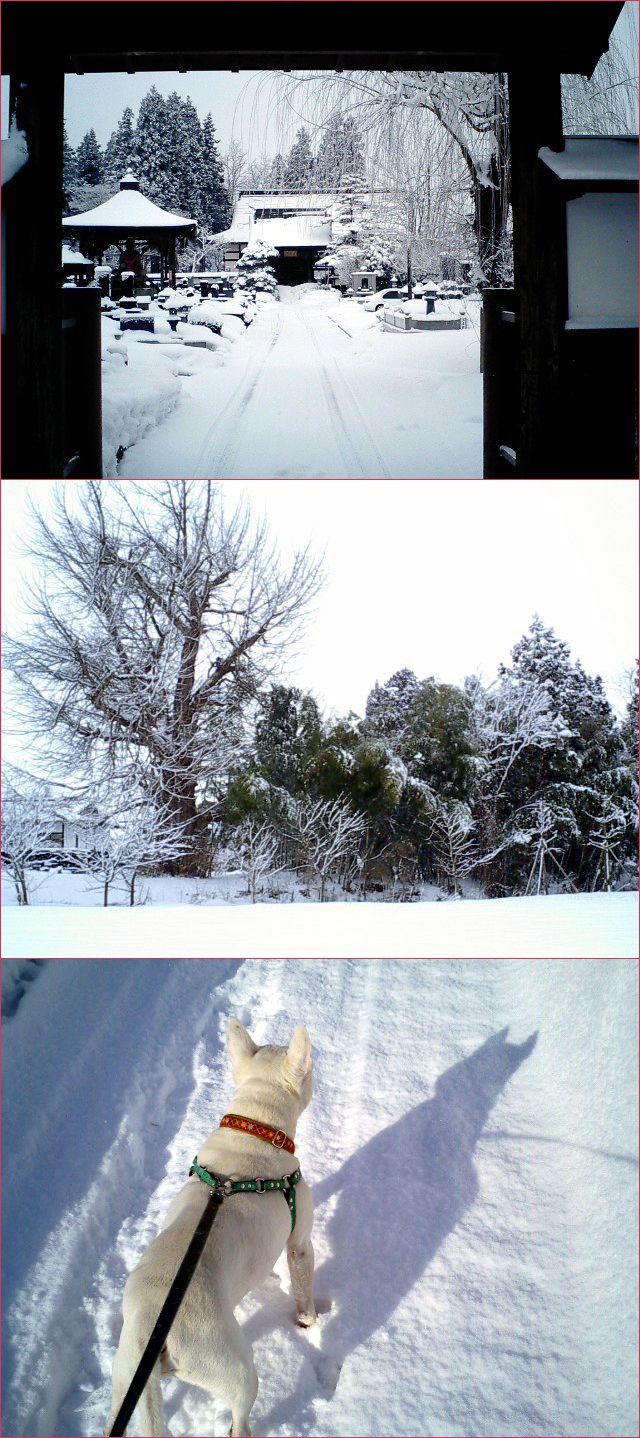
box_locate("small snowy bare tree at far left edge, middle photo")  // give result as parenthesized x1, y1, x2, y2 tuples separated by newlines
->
(1, 777, 58, 905)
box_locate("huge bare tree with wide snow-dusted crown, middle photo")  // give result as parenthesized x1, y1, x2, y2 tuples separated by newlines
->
(6, 480, 321, 873)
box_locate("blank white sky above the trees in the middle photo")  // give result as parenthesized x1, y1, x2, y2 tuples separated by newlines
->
(0, 480, 639, 736)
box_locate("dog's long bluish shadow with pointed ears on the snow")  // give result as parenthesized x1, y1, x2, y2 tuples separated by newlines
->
(244, 1028, 538, 1432)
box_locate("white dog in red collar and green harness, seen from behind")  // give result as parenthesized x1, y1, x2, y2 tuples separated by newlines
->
(106, 1018, 316, 1438)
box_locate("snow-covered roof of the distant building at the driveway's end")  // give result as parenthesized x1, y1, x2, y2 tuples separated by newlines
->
(216, 191, 334, 246)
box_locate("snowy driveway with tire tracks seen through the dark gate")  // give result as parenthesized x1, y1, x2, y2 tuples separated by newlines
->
(105, 285, 482, 479)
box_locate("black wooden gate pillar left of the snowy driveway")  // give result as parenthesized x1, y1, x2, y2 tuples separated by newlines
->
(1, 62, 65, 479)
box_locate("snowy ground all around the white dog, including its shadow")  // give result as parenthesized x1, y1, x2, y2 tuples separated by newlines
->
(3, 954, 639, 1438)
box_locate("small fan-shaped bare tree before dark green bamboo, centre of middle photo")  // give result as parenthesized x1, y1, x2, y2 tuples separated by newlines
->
(283, 800, 367, 903)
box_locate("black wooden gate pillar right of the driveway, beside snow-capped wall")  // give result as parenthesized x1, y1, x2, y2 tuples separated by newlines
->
(509, 65, 565, 479)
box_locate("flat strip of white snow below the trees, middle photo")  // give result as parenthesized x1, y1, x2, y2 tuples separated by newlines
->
(3, 876, 639, 958)
